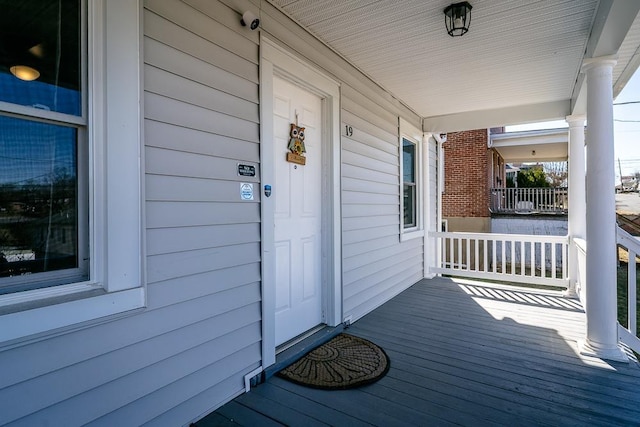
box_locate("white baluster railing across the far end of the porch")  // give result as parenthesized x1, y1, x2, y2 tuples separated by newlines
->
(429, 232, 569, 288)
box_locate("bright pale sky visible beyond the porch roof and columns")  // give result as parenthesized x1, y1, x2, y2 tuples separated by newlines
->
(507, 69, 640, 179)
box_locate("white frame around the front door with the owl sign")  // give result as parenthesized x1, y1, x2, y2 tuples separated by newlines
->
(260, 35, 342, 368)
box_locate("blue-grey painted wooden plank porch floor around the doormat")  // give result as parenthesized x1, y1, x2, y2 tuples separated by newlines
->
(197, 278, 640, 427)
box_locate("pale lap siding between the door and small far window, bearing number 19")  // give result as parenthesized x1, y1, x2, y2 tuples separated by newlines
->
(342, 91, 423, 320)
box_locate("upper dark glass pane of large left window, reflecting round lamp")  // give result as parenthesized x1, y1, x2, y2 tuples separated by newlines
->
(0, 0, 82, 116)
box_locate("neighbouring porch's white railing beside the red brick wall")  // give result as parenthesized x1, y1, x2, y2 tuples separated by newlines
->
(490, 187, 569, 214)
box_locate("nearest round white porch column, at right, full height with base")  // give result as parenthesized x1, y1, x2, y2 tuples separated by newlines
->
(580, 57, 627, 361)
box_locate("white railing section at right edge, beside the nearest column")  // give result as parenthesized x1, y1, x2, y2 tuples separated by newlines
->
(617, 227, 640, 353)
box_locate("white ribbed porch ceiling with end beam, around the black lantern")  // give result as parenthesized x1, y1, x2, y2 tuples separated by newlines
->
(269, 0, 640, 131)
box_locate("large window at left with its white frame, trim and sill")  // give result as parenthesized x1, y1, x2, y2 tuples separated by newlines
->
(0, 0, 144, 343)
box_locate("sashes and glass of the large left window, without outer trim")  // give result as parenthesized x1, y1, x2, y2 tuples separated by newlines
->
(0, 0, 90, 294)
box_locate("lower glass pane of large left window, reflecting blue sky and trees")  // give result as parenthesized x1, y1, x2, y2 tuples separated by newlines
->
(0, 117, 86, 293)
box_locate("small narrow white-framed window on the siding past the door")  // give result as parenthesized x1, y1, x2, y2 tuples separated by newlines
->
(400, 120, 424, 240)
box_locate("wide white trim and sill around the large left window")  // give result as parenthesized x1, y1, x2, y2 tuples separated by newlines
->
(0, 0, 146, 351)
